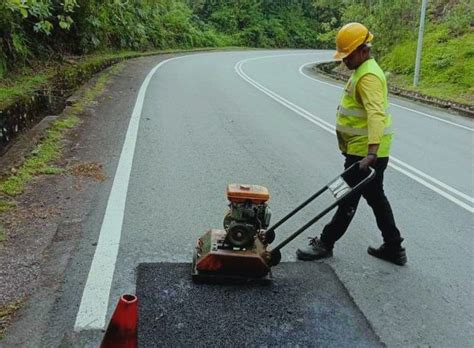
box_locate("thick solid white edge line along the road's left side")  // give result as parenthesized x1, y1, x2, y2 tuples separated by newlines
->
(74, 56, 188, 332)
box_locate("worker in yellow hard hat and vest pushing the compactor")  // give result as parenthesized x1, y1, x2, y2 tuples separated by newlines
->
(297, 23, 407, 266)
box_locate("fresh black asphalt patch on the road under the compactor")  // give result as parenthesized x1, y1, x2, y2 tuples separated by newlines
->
(136, 262, 383, 347)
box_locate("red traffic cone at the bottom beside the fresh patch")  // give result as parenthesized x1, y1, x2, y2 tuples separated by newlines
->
(100, 295, 138, 348)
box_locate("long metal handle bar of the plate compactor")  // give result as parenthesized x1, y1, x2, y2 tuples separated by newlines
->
(266, 162, 375, 252)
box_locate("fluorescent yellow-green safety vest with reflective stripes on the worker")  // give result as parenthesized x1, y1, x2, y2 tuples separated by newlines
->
(336, 58, 393, 157)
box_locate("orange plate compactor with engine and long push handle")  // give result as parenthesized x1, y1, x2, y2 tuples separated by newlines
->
(192, 163, 375, 281)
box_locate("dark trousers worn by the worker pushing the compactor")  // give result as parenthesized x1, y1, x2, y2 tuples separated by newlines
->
(321, 155, 403, 248)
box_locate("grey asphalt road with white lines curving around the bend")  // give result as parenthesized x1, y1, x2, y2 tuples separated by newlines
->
(6, 50, 474, 347)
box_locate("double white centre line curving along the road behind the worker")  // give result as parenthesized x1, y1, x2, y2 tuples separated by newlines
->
(234, 56, 474, 213)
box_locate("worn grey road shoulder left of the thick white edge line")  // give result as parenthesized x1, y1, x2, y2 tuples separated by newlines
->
(0, 55, 181, 346)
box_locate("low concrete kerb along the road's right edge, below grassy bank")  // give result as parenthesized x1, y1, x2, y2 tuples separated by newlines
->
(311, 61, 474, 118)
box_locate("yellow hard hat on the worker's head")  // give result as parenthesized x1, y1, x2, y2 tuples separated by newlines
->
(334, 23, 374, 60)
